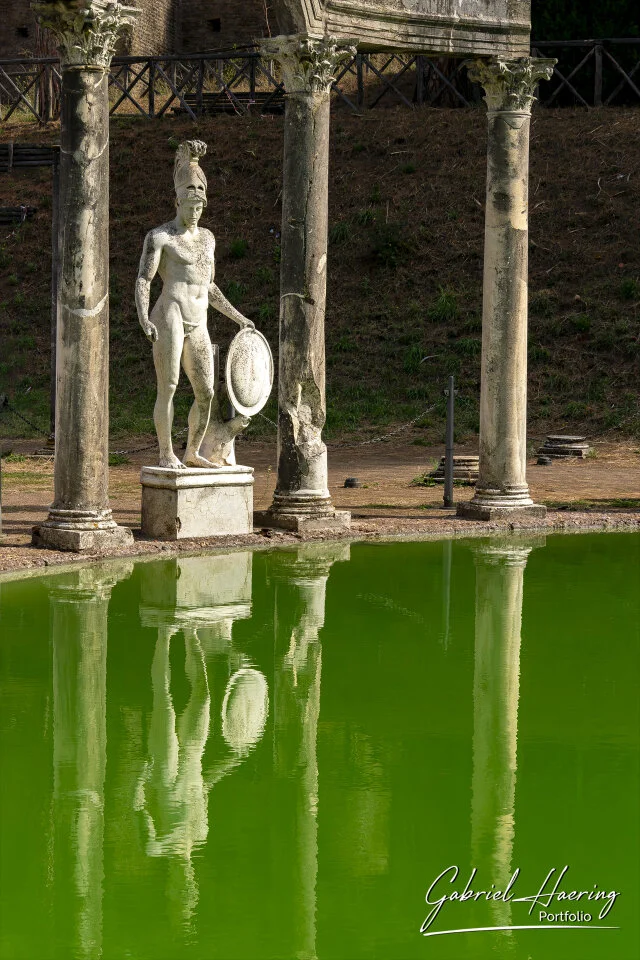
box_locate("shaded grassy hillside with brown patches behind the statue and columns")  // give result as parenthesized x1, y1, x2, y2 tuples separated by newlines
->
(0, 108, 640, 441)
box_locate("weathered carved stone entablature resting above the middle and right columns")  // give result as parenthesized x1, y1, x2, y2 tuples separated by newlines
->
(273, 0, 530, 57)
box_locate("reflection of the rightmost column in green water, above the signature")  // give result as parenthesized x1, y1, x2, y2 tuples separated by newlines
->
(471, 537, 545, 952)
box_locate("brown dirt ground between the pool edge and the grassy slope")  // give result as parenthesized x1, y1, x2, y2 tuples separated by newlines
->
(0, 437, 640, 571)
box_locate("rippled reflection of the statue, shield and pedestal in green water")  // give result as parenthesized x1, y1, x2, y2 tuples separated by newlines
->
(134, 552, 269, 929)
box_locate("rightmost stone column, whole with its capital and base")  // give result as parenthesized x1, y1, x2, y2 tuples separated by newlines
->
(457, 57, 555, 520)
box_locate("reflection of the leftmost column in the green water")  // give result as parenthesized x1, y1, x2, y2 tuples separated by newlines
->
(49, 561, 133, 960)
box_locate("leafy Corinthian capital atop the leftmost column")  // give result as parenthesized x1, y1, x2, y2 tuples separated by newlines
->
(31, 0, 140, 70)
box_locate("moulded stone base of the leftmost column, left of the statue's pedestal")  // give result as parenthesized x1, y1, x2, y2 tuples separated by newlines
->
(31, 510, 133, 553)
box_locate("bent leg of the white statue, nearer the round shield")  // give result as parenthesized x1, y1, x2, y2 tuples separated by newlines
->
(182, 324, 220, 467)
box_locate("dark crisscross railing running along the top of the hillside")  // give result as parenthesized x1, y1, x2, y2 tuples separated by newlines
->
(0, 39, 640, 123)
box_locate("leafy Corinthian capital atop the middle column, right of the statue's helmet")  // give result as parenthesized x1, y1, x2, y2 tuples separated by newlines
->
(260, 35, 356, 93)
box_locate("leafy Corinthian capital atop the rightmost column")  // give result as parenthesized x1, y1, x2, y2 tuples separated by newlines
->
(468, 57, 558, 114)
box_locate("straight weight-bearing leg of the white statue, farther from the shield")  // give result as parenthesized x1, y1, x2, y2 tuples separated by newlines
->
(151, 304, 184, 470)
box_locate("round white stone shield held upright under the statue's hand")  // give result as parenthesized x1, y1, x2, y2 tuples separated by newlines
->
(226, 327, 273, 417)
